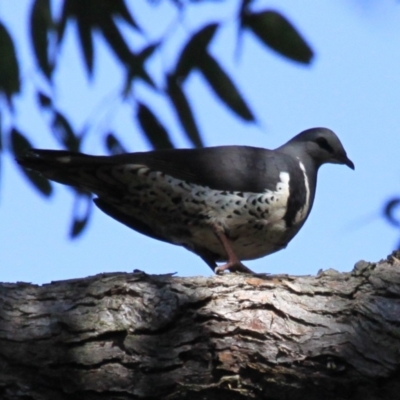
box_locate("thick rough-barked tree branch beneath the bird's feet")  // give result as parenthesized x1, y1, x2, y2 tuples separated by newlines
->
(0, 253, 400, 400)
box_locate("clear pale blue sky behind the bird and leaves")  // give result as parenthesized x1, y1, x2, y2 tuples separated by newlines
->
(0, 0, 400, 283)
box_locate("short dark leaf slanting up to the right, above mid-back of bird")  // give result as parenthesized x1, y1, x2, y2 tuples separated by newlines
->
(175, 24, 218, 83)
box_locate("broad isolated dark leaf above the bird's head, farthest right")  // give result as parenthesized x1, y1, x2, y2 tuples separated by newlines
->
(241, 11, 313, 64)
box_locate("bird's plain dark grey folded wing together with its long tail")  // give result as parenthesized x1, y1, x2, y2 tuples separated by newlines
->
(18, 146, 290, 192)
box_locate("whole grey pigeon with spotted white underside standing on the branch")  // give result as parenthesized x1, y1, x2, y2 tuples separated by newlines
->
(18, 128, 354, 272)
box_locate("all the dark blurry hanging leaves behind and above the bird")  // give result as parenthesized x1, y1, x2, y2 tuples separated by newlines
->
(0, 0, 313, 237)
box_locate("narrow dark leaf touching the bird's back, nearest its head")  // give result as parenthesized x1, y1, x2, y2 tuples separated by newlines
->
(167, 75, 203, 147)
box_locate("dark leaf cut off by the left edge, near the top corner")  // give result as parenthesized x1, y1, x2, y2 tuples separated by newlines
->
(0, 22, 20, 101)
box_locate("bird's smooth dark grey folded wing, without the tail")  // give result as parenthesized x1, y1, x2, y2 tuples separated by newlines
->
(105, 146, 285, 192)
